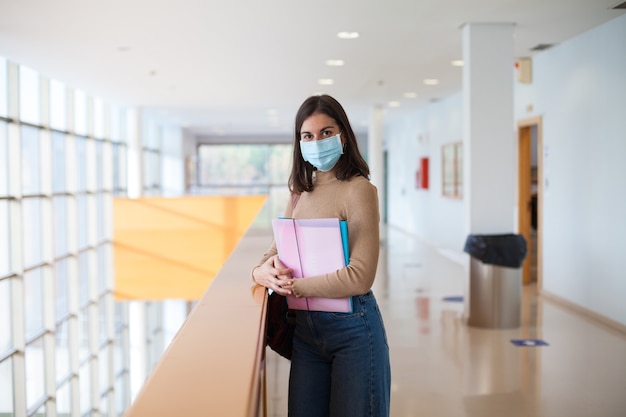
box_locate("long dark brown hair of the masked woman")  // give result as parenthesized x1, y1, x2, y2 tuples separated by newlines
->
(289, 94, 370, 194)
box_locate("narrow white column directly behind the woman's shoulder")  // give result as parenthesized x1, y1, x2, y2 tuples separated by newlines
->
(367, 106, 385, 226)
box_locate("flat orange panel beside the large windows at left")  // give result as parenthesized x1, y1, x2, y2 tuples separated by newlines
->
(113, 196, 266, 300)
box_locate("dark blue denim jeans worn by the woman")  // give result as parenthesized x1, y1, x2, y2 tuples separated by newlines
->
(289, 291, 391, 417)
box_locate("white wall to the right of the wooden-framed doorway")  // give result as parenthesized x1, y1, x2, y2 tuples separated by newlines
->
(516, 15, 626, 324)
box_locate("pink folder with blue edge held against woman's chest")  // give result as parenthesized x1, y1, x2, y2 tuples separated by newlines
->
(272, 218, 352, 313)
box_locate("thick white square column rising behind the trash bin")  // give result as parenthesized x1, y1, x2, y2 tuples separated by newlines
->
(462, 23, 517, 234)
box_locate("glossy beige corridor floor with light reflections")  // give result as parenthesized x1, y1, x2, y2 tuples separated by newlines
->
(267, 229, 626, 417)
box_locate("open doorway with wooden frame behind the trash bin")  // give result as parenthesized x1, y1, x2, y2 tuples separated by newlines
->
(517, 117, 543, 290)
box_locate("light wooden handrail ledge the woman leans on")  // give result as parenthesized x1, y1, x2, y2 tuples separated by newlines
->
(124, 230, 271, 417)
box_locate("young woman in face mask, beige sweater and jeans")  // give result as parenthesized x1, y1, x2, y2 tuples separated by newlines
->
(252, 95, 391, 417)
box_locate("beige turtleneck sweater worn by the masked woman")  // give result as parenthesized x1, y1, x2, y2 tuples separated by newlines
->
(256, 171, 380, 298)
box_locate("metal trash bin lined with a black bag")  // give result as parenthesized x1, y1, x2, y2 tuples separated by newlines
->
(463, 233, 527, 329)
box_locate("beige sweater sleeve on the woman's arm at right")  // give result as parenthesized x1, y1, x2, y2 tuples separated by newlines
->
(293, 181, 380, 298)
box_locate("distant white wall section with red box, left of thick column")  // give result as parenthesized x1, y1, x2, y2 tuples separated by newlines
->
(385, 92, 467, 252)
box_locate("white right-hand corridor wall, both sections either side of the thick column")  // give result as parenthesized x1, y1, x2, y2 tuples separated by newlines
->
(385, 15, 626, 325)
